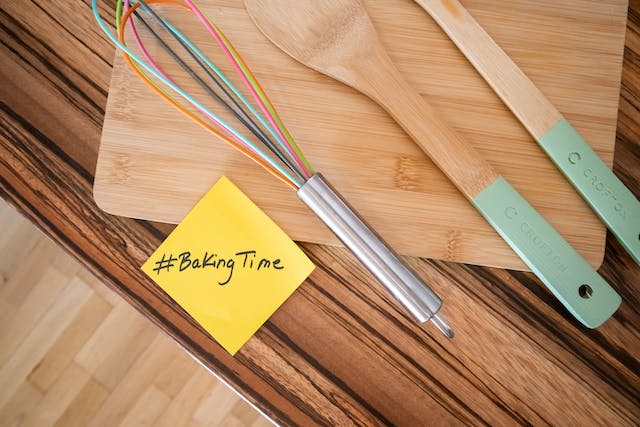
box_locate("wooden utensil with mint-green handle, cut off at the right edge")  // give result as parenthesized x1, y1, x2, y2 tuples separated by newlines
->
(415, 0, 640, 263)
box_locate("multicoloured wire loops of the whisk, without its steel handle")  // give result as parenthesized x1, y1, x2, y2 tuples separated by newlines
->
(92, 0, 313, 189)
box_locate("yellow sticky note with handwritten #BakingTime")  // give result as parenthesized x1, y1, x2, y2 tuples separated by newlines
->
(142, 177, 314, 354)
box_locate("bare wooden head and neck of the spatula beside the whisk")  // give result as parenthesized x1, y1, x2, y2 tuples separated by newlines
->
(245, 0, 499, 199)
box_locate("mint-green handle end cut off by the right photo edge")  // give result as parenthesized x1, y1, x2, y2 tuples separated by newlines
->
(538, 119, 640, 263)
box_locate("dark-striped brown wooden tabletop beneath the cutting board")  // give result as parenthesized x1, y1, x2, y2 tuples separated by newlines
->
(0, 0, 640, 426)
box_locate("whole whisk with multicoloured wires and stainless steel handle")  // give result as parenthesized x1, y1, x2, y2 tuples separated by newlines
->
(92, 0, 453, 338)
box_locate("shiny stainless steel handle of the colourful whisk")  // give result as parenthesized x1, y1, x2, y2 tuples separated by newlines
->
(297, 173, 453, 338)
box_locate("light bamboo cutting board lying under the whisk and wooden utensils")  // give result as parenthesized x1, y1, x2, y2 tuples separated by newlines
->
(94, 0, 627, 270)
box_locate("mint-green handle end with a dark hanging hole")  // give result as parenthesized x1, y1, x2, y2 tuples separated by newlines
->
(472, 177, 622, 328)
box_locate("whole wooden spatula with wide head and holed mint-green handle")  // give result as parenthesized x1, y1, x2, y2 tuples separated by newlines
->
(245, 0, 621, 328)
